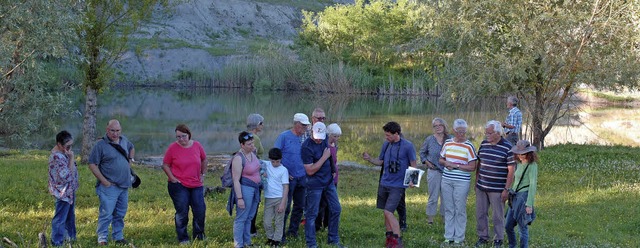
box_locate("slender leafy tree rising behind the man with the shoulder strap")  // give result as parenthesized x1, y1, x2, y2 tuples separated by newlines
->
(78, 0, 168, 162)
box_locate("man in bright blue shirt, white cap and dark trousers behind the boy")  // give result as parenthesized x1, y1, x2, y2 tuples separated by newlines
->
(273, 113, 311, 242)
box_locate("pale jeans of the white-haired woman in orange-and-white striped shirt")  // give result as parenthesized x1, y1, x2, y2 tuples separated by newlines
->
(440, 178, 469, 242)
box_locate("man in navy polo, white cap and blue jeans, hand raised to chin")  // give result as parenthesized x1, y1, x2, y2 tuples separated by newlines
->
(302, 122, 342, 247)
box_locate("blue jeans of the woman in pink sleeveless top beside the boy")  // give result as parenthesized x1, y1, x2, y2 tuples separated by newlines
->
(231, 185, 260, 247)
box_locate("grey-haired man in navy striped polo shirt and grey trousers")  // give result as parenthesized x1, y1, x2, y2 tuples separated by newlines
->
(475, 120, 515, 247)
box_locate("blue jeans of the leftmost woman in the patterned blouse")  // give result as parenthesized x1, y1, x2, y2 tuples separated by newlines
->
(51, 197, 76, 246)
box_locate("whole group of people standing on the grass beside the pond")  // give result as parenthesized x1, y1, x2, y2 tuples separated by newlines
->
(43, 97, 538, 247)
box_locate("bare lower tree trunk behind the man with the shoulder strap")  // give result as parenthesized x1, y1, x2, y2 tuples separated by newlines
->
(82, 87, 98, 163)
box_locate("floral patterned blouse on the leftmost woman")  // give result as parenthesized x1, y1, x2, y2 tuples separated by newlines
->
(49, 151, 78, 204)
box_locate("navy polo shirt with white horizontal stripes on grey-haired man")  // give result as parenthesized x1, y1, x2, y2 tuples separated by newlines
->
(476, 138, 515, 192)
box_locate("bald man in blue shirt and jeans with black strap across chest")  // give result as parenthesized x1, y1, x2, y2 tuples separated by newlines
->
(89, 120, 134, 246)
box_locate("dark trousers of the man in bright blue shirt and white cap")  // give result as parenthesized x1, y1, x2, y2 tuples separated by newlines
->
(282, 176, 306, 241)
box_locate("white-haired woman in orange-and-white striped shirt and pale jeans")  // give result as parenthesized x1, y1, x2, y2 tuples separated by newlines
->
(440, 119, 477, 245)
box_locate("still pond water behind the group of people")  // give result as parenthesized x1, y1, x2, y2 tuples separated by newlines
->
(44, 88, 636, 163)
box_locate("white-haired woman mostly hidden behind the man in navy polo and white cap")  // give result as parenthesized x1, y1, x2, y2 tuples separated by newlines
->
(316, 123, 342, 231)
